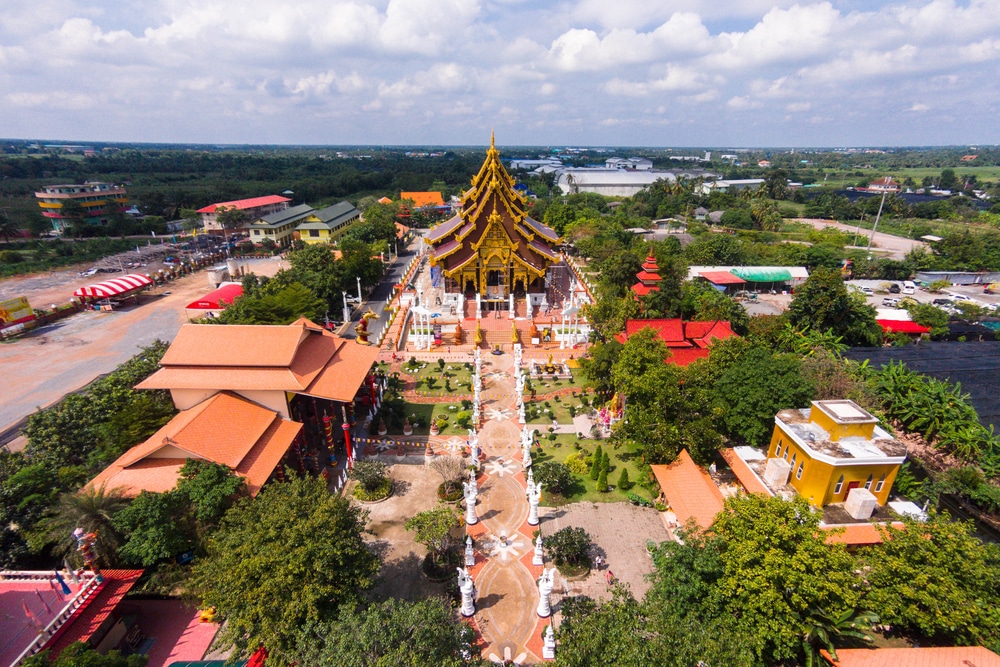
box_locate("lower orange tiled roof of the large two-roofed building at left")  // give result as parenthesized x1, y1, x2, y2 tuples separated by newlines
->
(89, 392, 304, 497)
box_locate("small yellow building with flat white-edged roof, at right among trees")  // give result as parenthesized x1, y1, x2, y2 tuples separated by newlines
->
(765, 400, 906, 507)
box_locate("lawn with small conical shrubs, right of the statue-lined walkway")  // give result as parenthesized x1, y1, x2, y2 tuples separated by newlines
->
(531, 433, 655, 506)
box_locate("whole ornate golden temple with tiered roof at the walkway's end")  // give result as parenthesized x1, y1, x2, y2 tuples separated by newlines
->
(426, 137, 560, 309)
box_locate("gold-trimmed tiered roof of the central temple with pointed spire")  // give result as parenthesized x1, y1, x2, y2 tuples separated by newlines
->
(425, 136, 559, 278)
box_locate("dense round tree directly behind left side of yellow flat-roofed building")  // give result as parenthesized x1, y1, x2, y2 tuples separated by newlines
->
(713, 347, 814, 445)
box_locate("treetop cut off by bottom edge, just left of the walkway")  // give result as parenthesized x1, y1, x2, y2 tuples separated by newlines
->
(296, 598, 481, 667)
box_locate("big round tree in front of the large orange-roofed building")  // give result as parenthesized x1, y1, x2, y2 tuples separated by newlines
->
(192, 477, 379, 663)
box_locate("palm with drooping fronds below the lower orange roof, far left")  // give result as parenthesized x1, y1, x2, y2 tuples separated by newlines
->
(41, 484, 129, 566)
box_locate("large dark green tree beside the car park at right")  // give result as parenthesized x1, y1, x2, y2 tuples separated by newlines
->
(788, 268, 882, 346)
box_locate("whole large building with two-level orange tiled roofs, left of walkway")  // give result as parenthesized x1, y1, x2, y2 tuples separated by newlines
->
(131, 318, 382, 490)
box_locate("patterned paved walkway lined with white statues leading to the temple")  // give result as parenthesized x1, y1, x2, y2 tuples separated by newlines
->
(466, 355, 549, 664)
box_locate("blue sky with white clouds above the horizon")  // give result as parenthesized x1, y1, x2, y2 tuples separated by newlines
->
(0, 0, 1000, 147)
